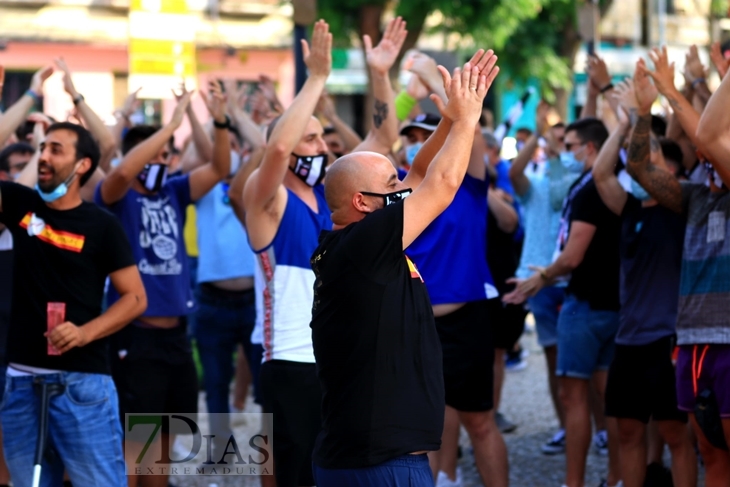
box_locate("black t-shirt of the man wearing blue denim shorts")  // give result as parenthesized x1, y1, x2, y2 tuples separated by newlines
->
(568, 178, 621, 311)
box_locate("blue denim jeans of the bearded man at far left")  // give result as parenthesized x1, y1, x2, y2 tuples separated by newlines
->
(0, 372, 127, 487)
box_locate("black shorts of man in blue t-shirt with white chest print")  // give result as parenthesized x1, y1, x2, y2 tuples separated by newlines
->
(111, 323, 198, 434)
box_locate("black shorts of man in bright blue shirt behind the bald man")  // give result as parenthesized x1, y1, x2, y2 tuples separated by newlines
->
(436, 300, 494, 411)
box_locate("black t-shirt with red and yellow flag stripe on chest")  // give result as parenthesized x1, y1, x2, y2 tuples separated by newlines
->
(0, 182, 135, 374)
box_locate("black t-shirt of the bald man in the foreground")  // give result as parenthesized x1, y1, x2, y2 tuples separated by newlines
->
(311, 203, 445, 468)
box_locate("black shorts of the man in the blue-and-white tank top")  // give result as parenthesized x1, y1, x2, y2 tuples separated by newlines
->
(260, 360, 322, 487)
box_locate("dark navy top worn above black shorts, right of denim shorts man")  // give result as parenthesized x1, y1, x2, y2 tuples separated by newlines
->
(616, 195, 685, 345)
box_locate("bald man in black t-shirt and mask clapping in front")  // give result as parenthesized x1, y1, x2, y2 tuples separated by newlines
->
(311, 51, 498, 487)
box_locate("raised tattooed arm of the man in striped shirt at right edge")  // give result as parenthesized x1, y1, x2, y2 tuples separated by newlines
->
(626, 113, 682, 213)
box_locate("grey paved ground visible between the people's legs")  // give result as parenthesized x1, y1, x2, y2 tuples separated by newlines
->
(172, 324, 703, 487)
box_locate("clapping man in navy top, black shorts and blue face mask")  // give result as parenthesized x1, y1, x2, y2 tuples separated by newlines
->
(593, 86, 697, 486)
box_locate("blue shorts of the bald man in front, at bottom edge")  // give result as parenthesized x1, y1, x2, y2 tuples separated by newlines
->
(313, 453, 434, 487)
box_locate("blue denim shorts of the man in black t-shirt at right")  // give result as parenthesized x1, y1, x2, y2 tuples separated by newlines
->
(555, 294, 619, 379)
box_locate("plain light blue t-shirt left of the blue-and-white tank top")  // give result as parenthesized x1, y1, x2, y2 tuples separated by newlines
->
(195, 183, 256, 283)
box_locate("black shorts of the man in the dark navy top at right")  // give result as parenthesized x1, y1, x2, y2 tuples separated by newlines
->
(606, 336, 687, 423)
